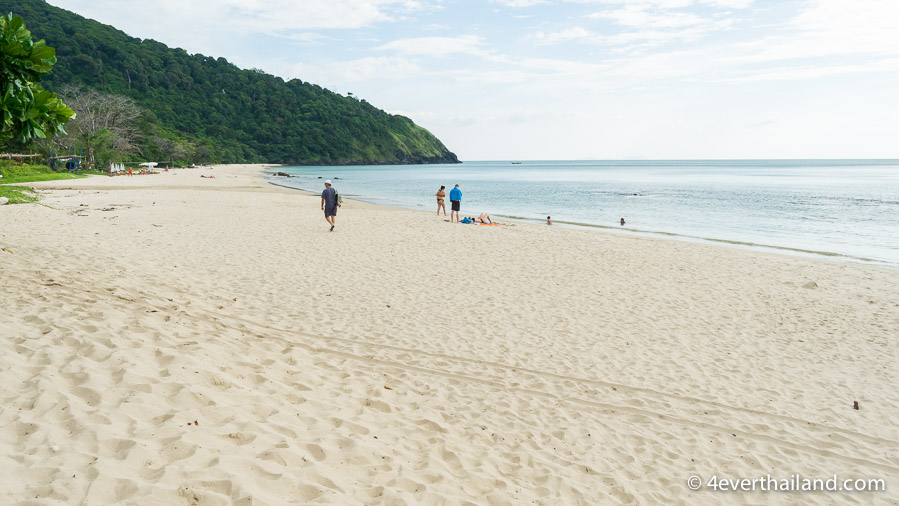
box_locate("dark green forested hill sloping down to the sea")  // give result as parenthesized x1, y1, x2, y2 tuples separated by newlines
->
(0, 0, 458, 164)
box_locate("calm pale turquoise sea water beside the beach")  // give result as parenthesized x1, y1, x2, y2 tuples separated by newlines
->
(270, 160, 899, 266)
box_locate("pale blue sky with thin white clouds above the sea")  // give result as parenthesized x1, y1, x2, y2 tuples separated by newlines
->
(49, 0, 899, 161)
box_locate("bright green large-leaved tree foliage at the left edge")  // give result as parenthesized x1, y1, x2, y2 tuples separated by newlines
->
(0, 13, 75, 142)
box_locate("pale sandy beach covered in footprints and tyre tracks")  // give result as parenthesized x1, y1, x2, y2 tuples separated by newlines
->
(0, 165, 899, 505)
